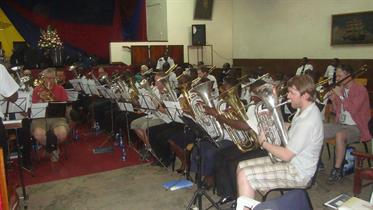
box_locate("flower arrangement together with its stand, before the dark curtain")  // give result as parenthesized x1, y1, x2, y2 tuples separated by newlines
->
(38, 25, 63, 66)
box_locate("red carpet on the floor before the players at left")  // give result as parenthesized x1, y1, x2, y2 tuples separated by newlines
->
(15, 127, 143, 185)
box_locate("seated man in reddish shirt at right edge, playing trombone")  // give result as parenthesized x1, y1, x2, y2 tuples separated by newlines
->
(324, 65, 372, 183)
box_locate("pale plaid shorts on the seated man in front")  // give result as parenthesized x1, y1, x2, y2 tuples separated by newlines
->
(238, 157, 310, 192)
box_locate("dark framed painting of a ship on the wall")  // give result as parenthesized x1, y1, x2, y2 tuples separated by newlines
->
(331, 11, 373, 45)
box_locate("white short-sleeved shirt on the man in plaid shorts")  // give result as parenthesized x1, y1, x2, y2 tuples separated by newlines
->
(286, 103, 324, 180)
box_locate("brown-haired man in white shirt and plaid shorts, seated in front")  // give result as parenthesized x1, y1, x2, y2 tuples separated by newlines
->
(237, 75, 324, 201)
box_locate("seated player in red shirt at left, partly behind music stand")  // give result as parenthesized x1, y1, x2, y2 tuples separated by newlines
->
(31, 68, 69, 161)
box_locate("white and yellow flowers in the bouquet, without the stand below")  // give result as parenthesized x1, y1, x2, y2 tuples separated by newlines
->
(38, 25, 62, 48)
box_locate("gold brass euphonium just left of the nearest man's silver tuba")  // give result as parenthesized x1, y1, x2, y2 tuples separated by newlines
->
(218, 88, 259, 152)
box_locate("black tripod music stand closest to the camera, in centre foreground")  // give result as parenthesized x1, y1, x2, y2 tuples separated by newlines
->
(181, 116, 221, 210)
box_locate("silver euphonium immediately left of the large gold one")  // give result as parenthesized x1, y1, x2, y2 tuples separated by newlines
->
(190, 81, 224, 141)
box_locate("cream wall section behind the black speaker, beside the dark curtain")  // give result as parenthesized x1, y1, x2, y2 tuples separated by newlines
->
(110, 0, 233, 67)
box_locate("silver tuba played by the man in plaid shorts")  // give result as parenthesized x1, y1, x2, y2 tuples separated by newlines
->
(253, 83, 288, 163)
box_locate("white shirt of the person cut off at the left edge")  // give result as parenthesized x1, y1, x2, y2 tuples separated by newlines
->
(0, 64, 19, 118)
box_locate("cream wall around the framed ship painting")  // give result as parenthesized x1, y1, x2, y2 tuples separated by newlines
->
(233, 0, 373, 59)
